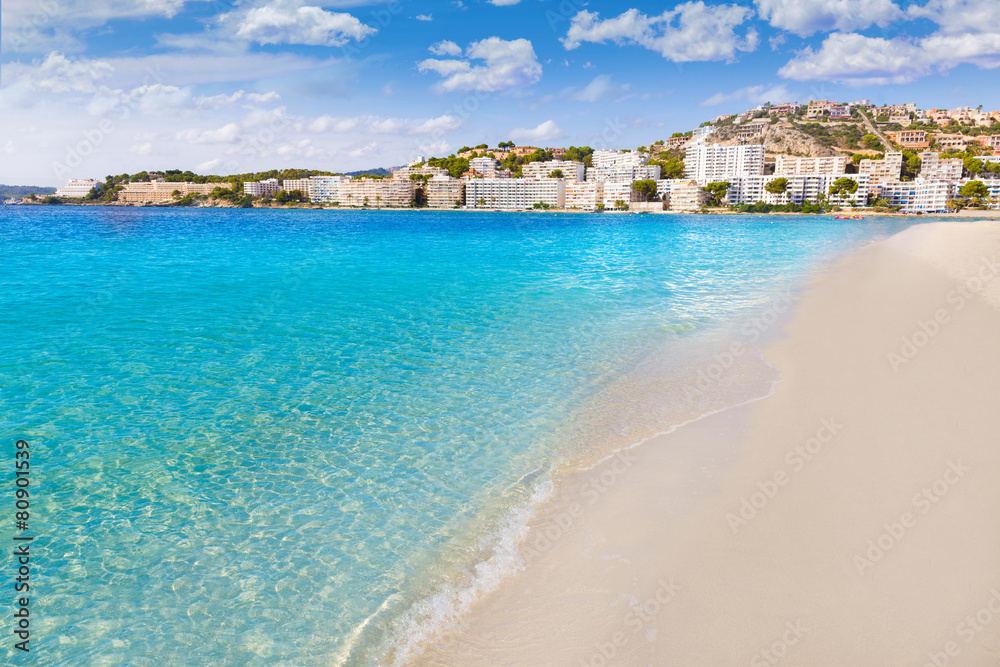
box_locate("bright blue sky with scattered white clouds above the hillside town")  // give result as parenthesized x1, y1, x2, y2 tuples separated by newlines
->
(0, 0, 1000, 185)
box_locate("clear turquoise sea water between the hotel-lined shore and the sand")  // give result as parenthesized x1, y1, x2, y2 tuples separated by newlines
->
(0, 207, 907, 665)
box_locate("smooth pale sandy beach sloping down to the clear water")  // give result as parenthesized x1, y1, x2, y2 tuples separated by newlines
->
(417, 222, 1000, 667)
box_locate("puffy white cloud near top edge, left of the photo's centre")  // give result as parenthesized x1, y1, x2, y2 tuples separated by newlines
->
(234, 0, 377, 46)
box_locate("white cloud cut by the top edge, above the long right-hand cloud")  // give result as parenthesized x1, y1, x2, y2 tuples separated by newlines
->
(754, 0, 904, 37)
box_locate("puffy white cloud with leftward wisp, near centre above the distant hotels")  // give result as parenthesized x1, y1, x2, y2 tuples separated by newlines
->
(417, 37, 542, 92)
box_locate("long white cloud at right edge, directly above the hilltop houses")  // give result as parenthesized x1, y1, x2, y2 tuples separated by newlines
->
(778, 32, 1000, 85)
